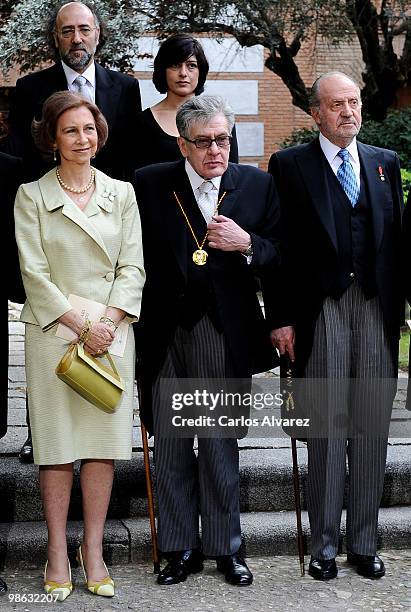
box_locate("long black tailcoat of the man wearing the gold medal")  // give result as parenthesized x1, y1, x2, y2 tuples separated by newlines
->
(134, 161, 279, 429)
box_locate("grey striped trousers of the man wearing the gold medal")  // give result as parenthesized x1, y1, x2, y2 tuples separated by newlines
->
(153, 316, 241, 556)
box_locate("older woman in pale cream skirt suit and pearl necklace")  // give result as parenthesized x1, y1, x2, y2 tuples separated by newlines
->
(15, 91, 145, 600)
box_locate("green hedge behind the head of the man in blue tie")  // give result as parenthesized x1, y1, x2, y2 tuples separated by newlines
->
(280, 108, 411, 175)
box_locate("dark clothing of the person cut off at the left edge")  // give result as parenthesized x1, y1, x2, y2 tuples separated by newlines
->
(0, 153, 25, 438)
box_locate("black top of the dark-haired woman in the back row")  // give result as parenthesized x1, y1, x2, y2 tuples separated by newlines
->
(135, 108, 238, 169)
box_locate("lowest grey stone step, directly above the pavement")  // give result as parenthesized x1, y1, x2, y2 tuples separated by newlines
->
(0, 507, 411, 576)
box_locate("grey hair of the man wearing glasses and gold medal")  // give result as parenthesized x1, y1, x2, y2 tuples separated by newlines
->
(176, 96, 235, 138)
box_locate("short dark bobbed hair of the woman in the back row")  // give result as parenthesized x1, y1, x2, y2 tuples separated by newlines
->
(153, 34, 209, 96)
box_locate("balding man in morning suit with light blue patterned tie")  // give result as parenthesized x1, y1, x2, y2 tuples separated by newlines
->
(266, 72, 403, 580)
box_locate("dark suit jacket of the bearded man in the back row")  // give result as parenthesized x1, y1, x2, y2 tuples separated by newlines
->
(7, 62, 141, 181)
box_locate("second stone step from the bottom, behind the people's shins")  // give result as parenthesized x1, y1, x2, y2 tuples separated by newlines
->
(0, 440, 411, 523)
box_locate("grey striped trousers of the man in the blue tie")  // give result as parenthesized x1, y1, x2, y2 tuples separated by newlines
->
(305, 282, 396, 559)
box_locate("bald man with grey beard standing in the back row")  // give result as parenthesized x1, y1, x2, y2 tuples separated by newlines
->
(7, 2, 141, 180)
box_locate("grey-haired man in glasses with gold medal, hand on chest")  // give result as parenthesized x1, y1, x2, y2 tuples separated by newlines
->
(135, 96, 279, 585)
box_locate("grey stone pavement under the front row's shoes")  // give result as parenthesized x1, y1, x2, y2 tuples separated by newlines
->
(0, 550, 411, 612)
